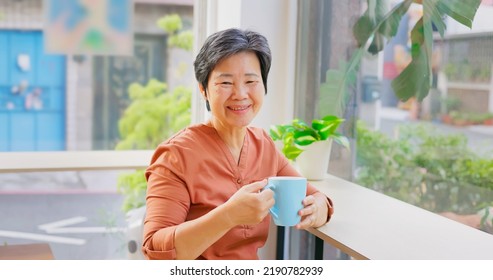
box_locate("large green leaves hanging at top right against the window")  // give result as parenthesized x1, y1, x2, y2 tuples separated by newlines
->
(320, 0, 481, 116)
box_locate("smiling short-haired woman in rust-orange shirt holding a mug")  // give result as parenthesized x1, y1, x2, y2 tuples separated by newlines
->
(142, 29, 332, 259)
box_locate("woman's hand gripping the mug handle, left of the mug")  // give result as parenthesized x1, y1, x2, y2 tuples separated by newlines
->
(224, 179, 274, 226)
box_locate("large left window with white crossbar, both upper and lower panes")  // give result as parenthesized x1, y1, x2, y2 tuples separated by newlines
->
(0, 0, 195, 259)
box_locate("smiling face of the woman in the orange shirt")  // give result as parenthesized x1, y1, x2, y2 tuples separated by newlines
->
(201, 51, 265, 129)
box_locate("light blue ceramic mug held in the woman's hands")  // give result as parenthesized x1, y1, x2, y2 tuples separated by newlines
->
(265, 176, 306, 226)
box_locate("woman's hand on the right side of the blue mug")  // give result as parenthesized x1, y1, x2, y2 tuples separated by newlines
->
(296, 193, 328, 229)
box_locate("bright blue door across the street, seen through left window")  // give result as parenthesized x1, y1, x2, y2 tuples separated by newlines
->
(0, 30, 65, 151)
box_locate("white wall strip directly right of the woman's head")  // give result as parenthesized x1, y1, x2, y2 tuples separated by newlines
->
(241, 0, 297, 129)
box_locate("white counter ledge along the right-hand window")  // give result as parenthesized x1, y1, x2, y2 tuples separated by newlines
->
(309, 175, 493, 260)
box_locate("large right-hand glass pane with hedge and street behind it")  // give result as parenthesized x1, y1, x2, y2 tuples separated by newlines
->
(295, 1, 493, 258)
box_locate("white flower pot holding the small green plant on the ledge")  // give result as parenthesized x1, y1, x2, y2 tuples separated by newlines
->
(296, 139, 332, 180)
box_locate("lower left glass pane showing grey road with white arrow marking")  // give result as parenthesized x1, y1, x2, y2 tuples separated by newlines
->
(0, 171, 130, 260)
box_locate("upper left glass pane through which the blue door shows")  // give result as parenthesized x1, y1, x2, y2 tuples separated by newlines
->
(0, 0, 195, 152)
